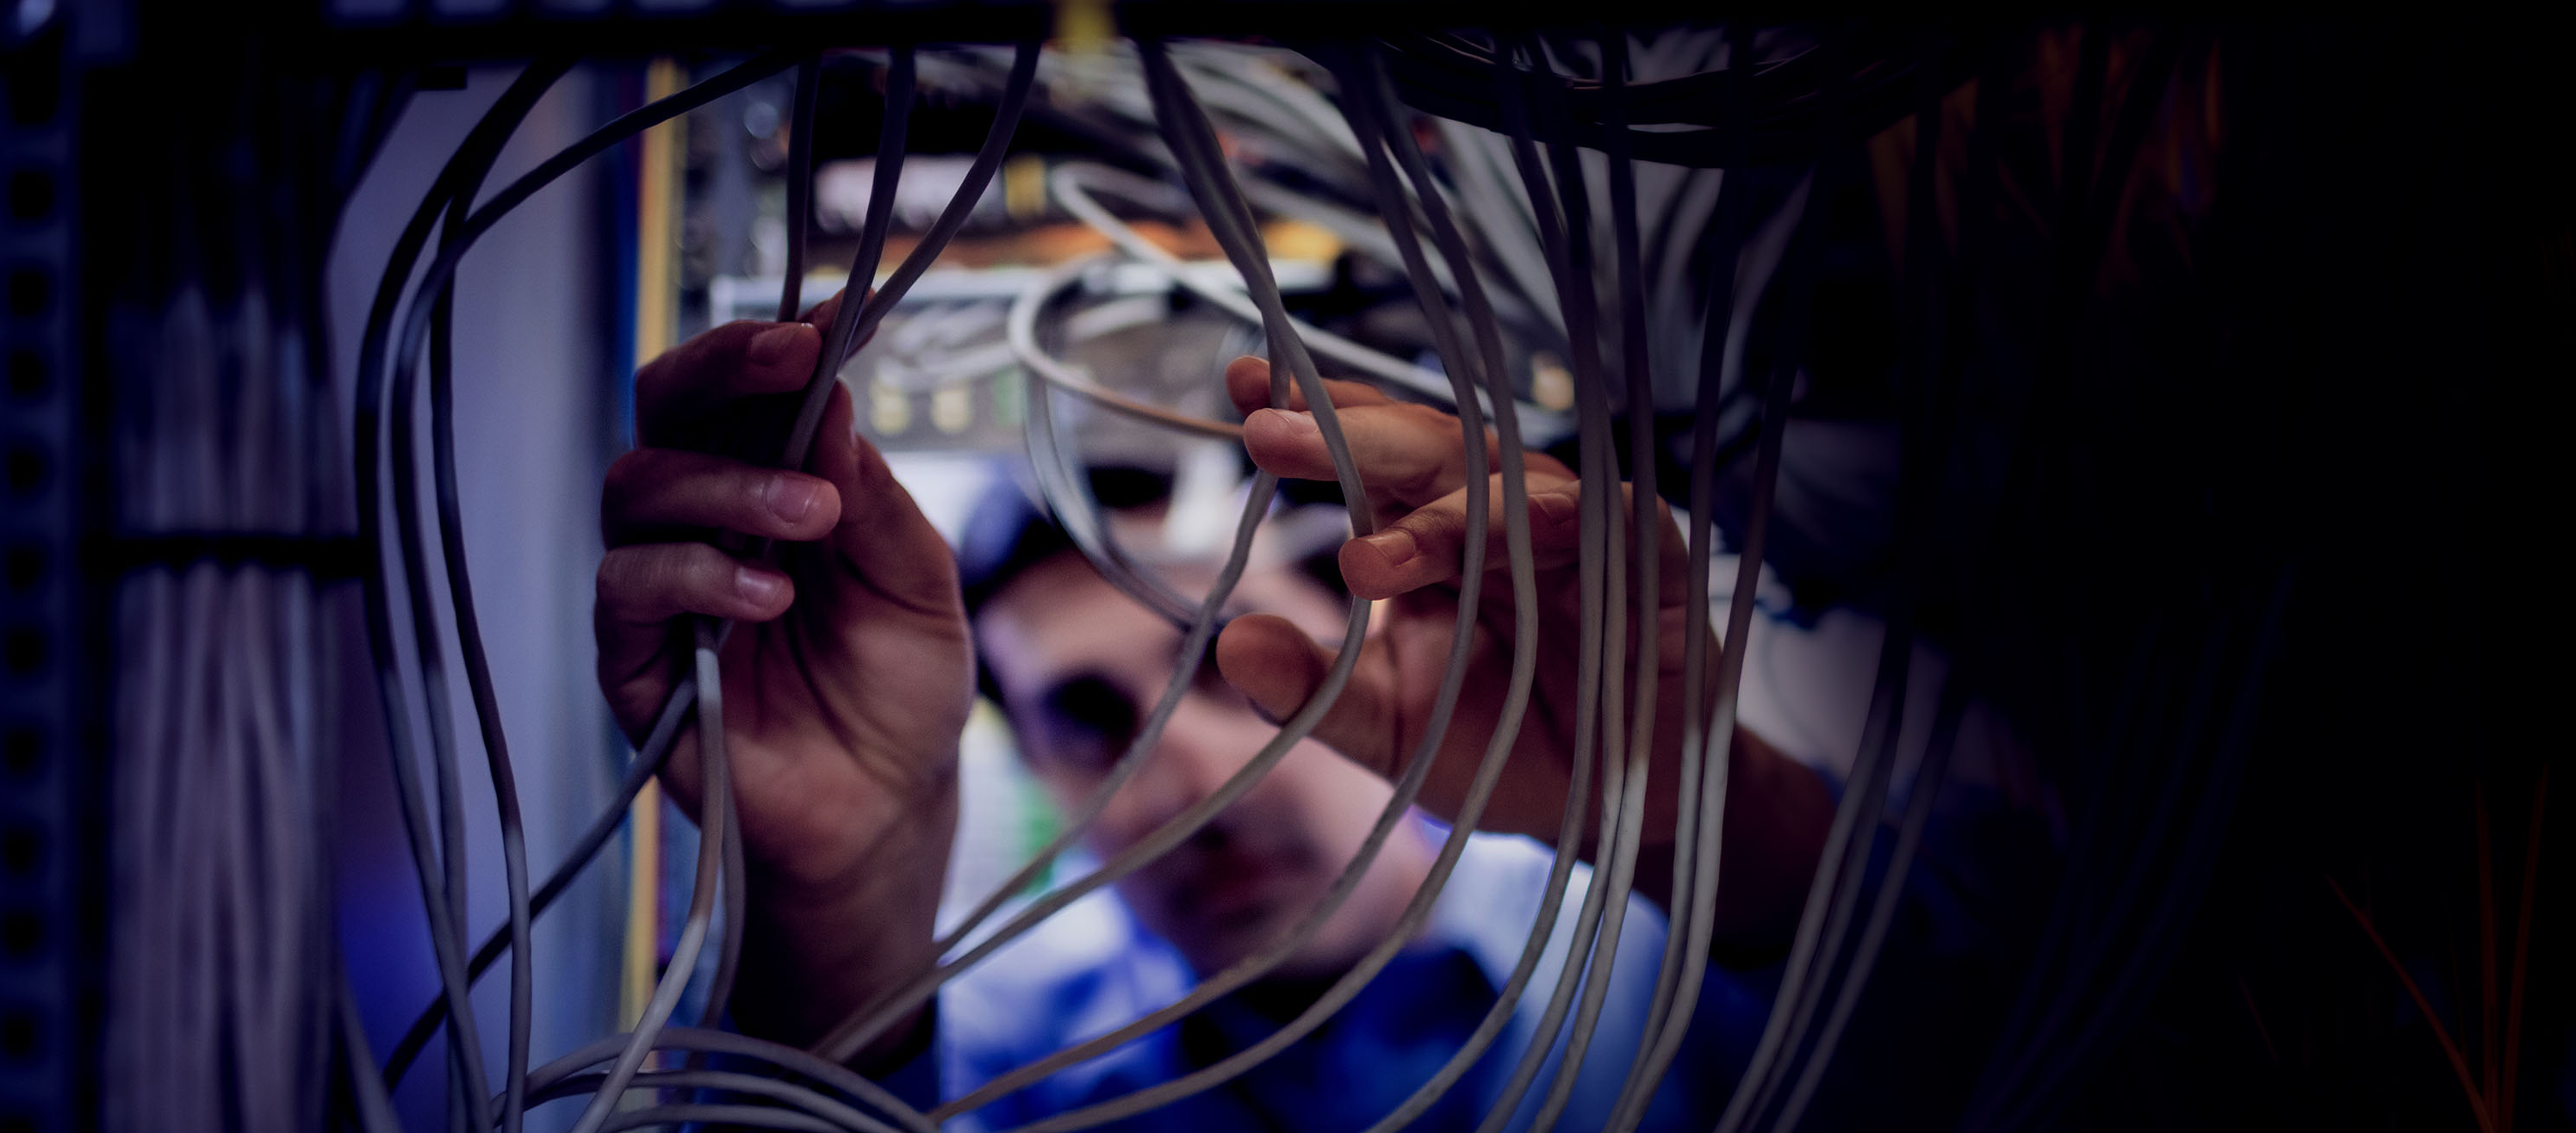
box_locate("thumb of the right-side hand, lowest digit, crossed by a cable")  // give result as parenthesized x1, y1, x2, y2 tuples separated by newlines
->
(1216, 613, 1401, 775)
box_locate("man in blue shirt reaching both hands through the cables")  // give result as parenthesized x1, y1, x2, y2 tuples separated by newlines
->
(598, 304, 1829, 1130)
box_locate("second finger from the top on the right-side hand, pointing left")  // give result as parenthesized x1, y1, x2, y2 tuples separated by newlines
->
(1245, 405, 1556, 507)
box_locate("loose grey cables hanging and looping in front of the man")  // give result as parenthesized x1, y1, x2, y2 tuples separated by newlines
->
(321, 26, 1947, 1133)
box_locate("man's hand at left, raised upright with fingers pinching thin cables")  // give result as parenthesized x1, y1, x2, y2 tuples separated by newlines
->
(595, 299, 974, 1043)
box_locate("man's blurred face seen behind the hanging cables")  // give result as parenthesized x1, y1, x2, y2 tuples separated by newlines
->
(977, 551, 1430, 976)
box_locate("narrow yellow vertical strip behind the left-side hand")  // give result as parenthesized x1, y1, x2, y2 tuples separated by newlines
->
(618, 59, 688, 1030)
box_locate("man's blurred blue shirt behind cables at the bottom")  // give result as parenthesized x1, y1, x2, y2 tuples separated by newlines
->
(886, 834, 1770, 1133)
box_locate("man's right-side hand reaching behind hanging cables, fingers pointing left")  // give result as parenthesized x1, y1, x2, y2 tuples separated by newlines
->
(1216, 358, 1832, 943)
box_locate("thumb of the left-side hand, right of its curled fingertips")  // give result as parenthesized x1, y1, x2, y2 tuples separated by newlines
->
(811, 387, 964, 616)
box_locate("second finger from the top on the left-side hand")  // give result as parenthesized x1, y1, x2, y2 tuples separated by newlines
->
(600, 448, 840, 546)
